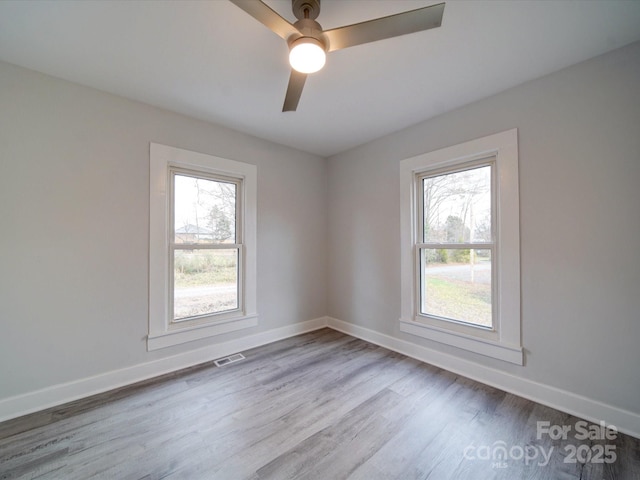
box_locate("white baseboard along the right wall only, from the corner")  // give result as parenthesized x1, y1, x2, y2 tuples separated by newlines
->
(327, 318, 640, 438)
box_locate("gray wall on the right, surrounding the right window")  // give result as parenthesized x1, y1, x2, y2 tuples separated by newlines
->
(328, 43, 640, 413)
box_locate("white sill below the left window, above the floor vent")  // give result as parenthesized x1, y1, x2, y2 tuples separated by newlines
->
(147, 314, 258, 351)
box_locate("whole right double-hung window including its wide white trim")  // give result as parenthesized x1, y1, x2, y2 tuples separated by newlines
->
(400, 129, 523, 365)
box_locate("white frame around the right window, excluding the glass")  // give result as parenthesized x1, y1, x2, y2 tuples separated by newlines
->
(400, 129, 524, 365)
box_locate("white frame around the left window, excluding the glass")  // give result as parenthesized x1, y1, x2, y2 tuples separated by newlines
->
(147, 143, 258, 351)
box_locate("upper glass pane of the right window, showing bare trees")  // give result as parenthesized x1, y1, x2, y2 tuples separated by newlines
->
(422, 165, 491, 243)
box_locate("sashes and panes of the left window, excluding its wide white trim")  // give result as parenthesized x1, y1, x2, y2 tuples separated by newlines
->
(169, 167, 243, 322)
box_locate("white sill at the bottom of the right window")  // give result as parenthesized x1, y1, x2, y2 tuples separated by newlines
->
(400, 318, 524, 365)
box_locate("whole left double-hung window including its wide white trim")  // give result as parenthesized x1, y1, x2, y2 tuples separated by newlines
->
(147, 143, 257, 350)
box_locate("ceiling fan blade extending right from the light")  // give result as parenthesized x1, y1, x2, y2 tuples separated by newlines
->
(324, 3, 444, 52)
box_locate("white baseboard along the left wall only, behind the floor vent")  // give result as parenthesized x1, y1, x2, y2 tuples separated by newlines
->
(0, 317, 327, 422)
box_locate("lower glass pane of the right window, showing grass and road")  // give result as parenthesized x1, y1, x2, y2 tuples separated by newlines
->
(420, 248, 492, 327)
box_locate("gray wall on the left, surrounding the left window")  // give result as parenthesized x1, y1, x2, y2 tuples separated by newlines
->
(0, 63, 326, 400)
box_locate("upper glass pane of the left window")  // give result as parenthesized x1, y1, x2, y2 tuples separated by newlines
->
(174, 174, 237, 244)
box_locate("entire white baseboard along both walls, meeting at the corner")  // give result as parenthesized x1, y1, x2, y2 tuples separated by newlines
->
(0, 317, 640, 438)
